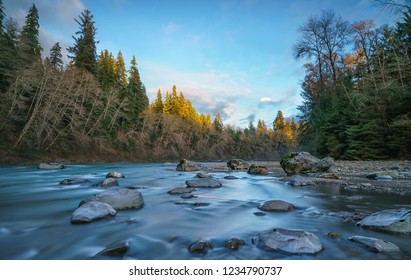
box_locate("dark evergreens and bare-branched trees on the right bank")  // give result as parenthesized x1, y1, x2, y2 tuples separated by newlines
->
(294, 1, 411, 160)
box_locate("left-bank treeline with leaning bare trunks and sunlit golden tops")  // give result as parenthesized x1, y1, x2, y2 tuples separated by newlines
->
(0, 0, 299, 163)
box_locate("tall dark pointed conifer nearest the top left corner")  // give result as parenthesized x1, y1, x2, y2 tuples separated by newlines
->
(19, 4, 42, 67)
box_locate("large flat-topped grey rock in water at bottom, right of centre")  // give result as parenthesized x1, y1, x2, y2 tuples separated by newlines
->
(254, 228, 323, 254)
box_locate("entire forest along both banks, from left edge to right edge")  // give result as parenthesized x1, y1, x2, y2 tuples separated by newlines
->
(0, 0, 411, 163)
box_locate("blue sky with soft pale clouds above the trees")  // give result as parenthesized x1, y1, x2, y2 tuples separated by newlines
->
(3, 0, 395, 127)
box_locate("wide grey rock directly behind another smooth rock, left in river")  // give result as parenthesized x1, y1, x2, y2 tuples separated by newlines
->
(80, 188, 144, 210)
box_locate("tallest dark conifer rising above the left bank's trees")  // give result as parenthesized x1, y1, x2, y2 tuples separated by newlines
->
(67, 9, 98, 74)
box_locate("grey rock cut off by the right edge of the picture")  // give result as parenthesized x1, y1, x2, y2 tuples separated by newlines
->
(357, 208, 411, 234)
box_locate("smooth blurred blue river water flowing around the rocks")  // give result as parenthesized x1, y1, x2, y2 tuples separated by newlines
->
(0, 163, 411, 260)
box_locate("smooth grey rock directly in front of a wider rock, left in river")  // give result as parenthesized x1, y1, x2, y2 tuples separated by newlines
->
(71, 201, 117, 224)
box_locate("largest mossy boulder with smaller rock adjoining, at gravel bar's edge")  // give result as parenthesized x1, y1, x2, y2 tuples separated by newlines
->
(280, 152, 336, 175)
